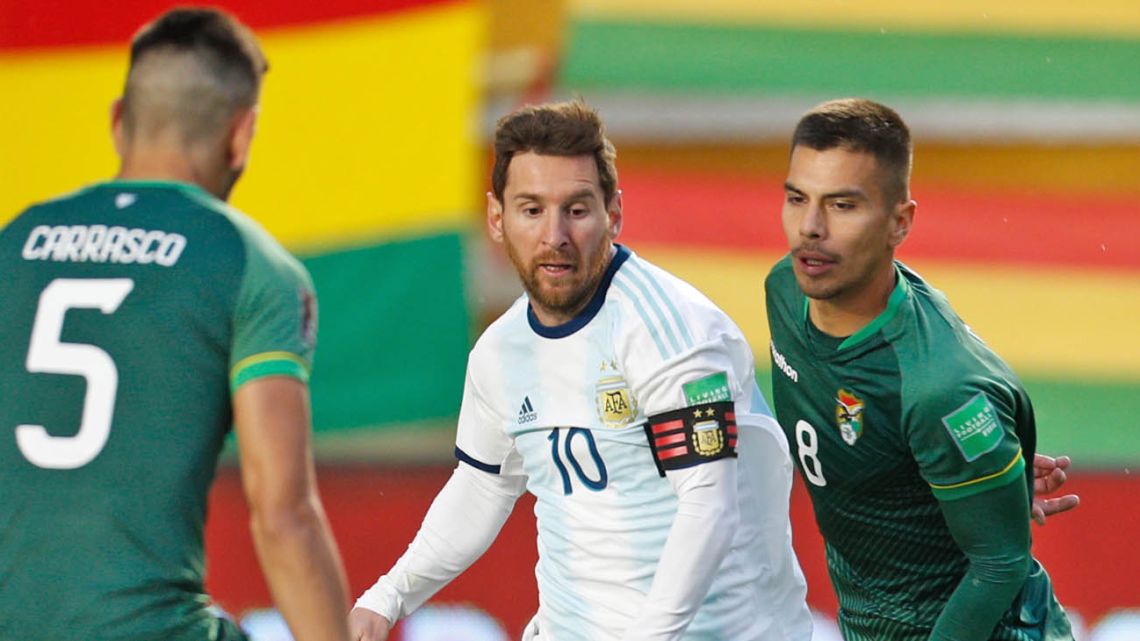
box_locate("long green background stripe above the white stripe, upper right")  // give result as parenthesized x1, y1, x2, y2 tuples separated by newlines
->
(561, 19, 1140, 100)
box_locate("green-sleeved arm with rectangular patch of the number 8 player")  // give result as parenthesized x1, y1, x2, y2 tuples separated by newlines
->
(906, 376, 1033, 641)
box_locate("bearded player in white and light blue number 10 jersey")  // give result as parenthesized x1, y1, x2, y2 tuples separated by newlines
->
(350, 102, 811, 641)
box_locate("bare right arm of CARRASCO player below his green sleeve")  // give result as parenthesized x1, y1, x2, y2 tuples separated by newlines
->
(233, 376, 348, 641)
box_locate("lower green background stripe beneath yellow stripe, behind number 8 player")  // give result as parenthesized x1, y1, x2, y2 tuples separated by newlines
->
(756, 367, 1140, 469)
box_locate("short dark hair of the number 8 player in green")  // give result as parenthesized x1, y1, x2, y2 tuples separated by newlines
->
(791, 98, 913, 200)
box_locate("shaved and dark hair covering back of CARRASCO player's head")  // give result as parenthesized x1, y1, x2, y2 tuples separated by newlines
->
(122, 8, 269, 147)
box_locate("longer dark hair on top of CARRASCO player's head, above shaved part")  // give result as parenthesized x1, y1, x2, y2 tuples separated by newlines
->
(130, 7, 269, 94)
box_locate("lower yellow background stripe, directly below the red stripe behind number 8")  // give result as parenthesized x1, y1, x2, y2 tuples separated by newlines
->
(634, 243, 1140, 381)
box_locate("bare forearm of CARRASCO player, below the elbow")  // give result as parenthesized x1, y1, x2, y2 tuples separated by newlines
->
(250, 497, 348, 641)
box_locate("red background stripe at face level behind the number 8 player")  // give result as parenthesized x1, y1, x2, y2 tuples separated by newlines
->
(621, 169, 1140, 269)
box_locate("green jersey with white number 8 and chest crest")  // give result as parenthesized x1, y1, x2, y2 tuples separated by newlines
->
(765, 258, 1069, 641)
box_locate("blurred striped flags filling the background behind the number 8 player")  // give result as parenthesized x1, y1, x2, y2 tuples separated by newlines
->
(557, 0, 1140, 466)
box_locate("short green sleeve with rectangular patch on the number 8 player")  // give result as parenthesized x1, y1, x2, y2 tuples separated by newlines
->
(904, 376, 1029, 501)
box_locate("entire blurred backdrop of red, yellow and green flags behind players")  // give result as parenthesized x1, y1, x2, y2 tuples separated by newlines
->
(0, 0, 1140, 635)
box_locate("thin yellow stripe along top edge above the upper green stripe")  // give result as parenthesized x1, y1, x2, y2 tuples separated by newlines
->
(570, 0, 1140, 35)
